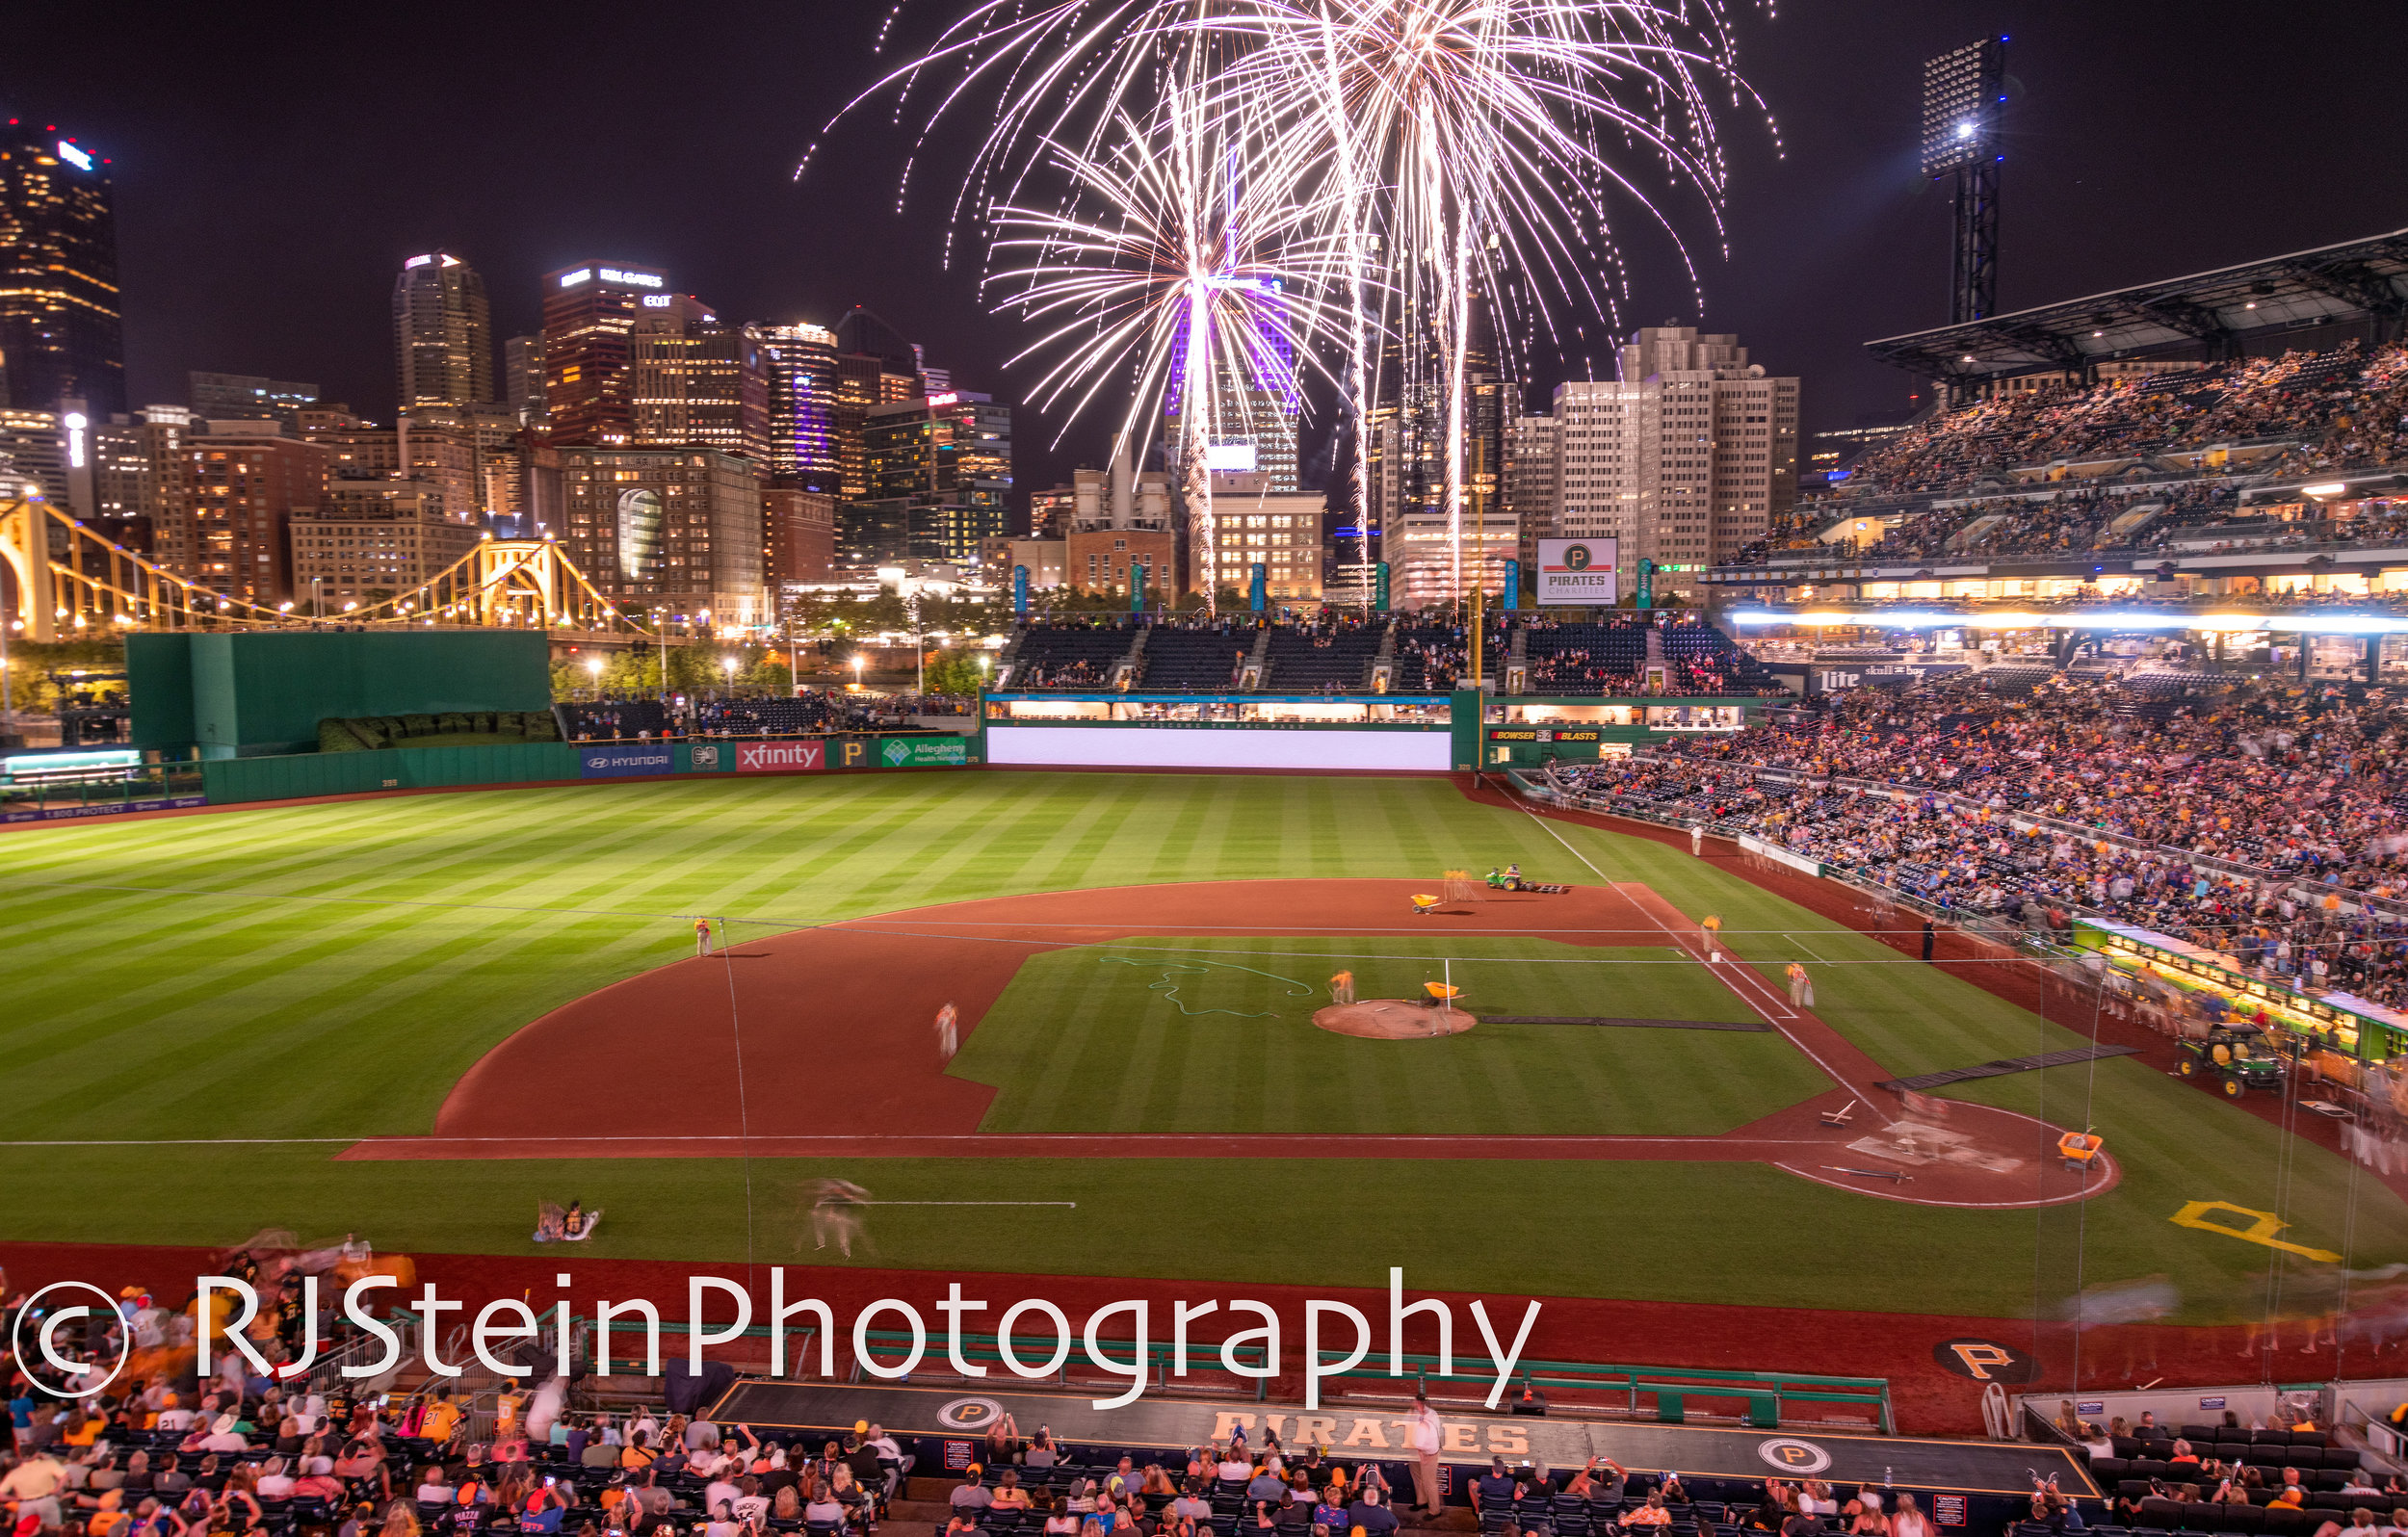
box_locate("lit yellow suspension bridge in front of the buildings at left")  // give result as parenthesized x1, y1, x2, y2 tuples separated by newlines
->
(0, 496, 653, 640)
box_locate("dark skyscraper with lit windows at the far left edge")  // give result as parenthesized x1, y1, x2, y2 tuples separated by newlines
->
(0, 118, 125, 422)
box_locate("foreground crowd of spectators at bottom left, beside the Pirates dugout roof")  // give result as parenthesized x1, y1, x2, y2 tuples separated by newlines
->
(0, 1253, 910, 1537)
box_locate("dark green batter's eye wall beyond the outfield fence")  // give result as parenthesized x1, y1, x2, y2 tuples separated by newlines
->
(125, 629, 552, 759)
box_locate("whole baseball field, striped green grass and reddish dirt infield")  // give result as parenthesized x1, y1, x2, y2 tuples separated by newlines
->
(0, 773, 2408, 1356)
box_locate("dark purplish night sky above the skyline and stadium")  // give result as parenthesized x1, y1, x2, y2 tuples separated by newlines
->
(0, 0, 2408, 501)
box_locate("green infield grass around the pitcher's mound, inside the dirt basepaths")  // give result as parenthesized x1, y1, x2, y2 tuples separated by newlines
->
(952, 935, 1830, 1137)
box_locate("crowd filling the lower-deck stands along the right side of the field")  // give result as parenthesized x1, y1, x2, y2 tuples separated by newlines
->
(1551, 674, 2408, 1007)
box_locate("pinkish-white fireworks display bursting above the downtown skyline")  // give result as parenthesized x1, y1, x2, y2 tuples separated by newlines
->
(828, 0, 1770, 612)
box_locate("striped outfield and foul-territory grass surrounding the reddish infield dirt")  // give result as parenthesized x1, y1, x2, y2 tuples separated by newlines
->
(0, 773, 2408, 1320)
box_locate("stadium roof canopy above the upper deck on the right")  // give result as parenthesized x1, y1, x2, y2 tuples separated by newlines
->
(1864, 229, 2408, 380)
